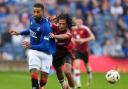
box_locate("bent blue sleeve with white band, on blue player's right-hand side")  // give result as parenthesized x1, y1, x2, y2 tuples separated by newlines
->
(30, 23, 52, 51)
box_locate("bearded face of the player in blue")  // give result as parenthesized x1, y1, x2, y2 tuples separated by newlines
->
(32, 7, 43, 21)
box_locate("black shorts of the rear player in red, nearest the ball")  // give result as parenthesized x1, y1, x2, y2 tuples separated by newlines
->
(73, 51, 89, 63)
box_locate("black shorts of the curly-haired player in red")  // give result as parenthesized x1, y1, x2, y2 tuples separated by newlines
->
(53, 49, 73, 68)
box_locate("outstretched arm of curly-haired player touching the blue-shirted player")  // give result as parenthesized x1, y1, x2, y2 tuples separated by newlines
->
(50, 33, 71, 40)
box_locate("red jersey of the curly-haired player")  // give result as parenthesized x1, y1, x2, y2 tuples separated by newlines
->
(52, 24, 73, 53)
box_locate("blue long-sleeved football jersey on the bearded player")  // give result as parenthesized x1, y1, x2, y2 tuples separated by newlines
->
(21, 17, 56, 54)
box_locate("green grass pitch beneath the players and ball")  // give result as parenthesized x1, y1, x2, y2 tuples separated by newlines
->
(0, 72, 128, 89)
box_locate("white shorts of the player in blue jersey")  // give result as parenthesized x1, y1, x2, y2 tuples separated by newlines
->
(28, 49, 53, 73)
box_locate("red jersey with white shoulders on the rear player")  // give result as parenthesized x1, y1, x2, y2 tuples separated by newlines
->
(71, 26, 90, 52)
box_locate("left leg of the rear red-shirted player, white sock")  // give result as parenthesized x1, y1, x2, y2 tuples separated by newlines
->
(73, 59, 81, 88)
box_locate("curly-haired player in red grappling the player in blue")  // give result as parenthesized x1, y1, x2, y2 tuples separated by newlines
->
(50, 14, 75, 89)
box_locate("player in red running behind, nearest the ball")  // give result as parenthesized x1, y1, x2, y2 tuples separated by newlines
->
(71, 18, 95, 87)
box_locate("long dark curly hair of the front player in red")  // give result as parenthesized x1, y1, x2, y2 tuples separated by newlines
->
(57, 14, 72, 29)
